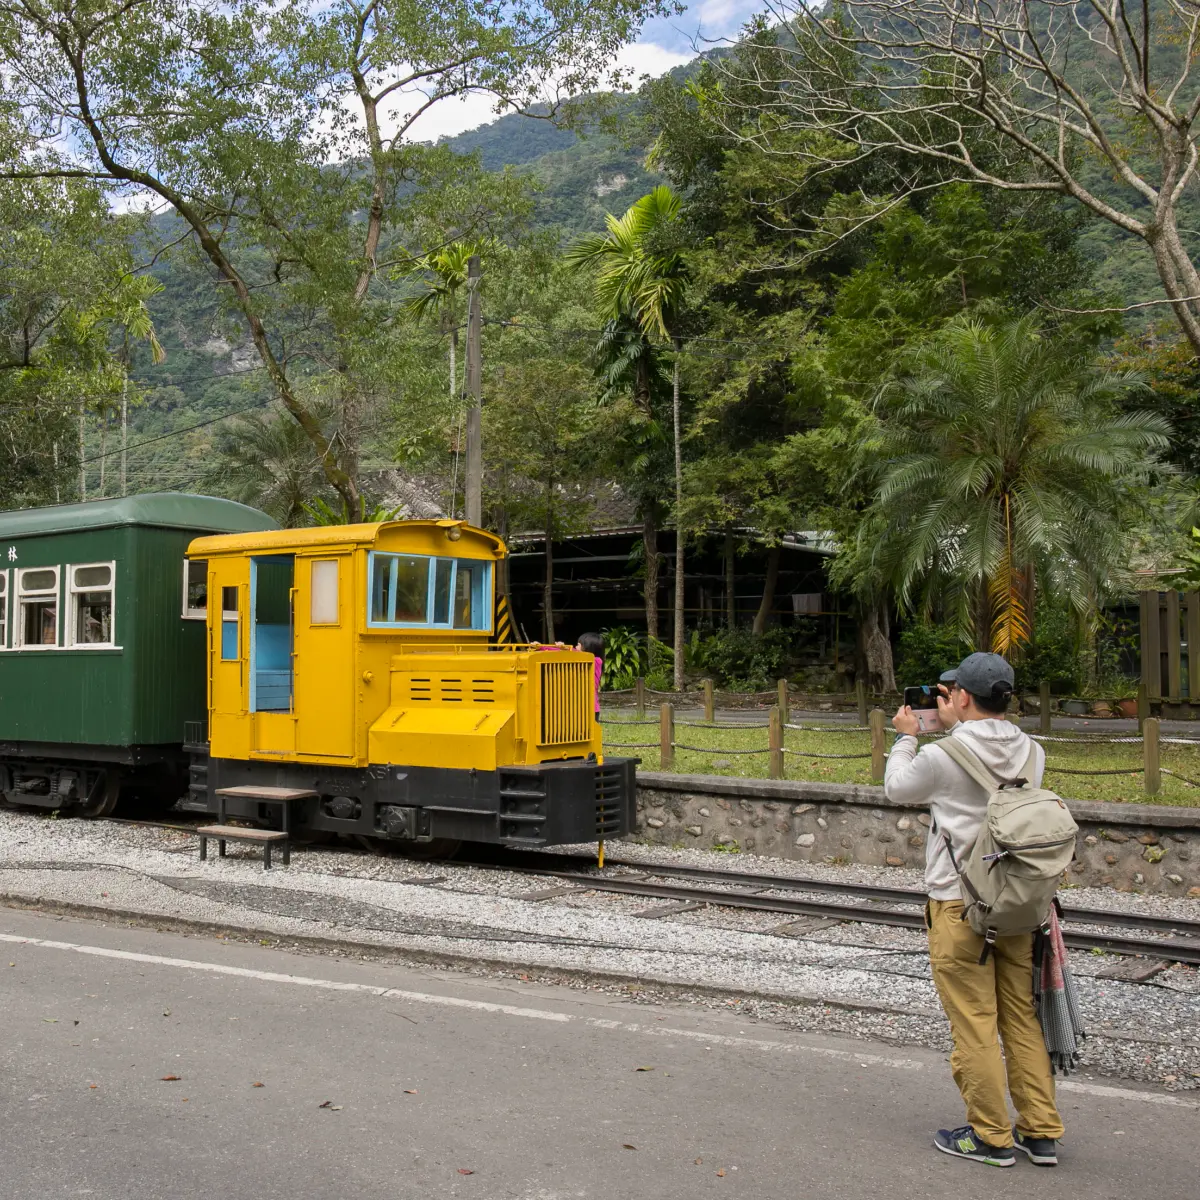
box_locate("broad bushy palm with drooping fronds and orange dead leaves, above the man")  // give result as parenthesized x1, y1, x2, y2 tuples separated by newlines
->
(864, 317, 1170, 654)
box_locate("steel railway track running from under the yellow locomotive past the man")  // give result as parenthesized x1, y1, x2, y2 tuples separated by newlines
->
(114, 818, 1200, 966)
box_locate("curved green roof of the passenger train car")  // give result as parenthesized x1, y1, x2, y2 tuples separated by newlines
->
(0, 492, 278, 541)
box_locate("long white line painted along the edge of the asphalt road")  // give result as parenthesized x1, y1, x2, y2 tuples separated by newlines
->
(0, 934, 1200, 1109)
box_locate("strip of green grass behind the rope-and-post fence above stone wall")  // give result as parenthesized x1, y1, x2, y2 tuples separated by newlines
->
(604, 713, 1200, 806)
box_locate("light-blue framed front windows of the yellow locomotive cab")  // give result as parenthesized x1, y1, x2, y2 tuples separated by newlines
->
(367, 551, 492, 630)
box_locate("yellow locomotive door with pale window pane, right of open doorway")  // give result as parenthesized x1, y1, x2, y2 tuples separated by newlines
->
(293, 552, 356, 758)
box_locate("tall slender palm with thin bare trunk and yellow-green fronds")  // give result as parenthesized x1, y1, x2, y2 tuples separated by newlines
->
(566, 186, 688, 691)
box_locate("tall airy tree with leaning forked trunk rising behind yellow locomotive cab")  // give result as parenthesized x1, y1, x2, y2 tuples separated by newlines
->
(0, 0, 660, 512)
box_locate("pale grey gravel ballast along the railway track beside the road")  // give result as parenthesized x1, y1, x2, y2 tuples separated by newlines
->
(0, 811, 1200, 1088)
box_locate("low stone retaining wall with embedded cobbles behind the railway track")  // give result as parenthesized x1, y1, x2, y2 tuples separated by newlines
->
(637, 772, 1200, 898)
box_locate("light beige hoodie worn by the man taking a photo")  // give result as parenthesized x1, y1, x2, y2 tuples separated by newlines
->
(883, 718, 1046, 900)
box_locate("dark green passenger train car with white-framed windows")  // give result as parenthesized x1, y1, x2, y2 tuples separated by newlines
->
(0, 492, 276, 816)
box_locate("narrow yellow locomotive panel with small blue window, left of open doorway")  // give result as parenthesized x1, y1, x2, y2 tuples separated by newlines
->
(209, 558, 251, 758)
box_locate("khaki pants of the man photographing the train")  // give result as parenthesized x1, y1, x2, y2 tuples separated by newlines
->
(928, 900, 1062, 1146)
